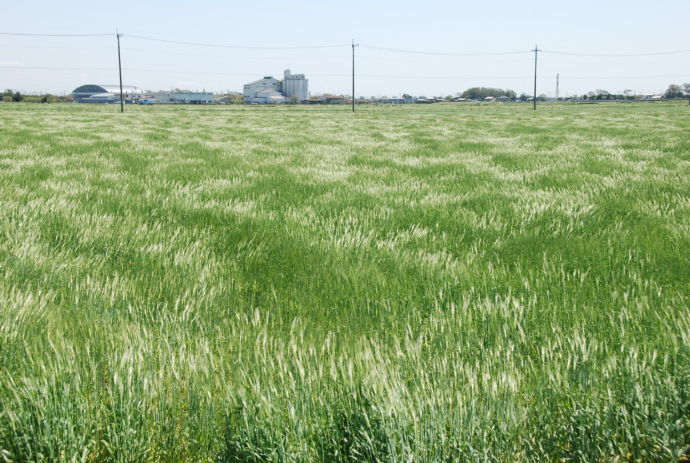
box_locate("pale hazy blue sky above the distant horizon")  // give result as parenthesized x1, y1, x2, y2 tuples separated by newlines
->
(0, 0, 690, 96)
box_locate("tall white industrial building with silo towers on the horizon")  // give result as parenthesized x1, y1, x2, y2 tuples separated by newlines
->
(244, 69, 309, 104)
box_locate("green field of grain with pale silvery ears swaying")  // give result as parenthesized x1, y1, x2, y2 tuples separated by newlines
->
(0, 102, 690, 463)
